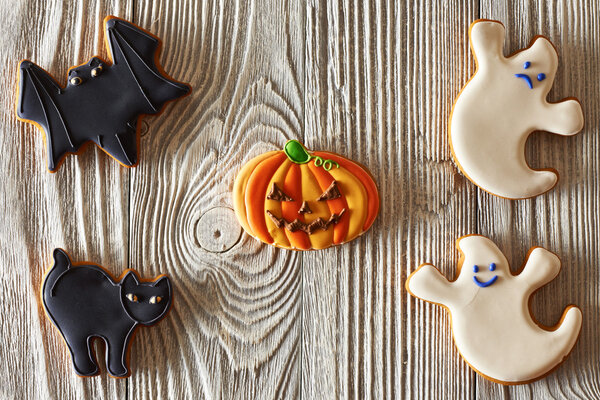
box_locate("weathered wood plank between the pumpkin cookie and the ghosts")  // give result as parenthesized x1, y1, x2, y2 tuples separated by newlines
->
(302, 1, 478, 398)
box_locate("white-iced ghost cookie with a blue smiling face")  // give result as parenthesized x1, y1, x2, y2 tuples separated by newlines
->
(406, 235, 582, 385)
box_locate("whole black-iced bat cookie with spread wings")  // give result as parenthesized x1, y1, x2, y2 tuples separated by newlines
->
(17, 16, 191, 172)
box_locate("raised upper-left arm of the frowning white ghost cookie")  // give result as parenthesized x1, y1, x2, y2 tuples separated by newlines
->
(469, 20, 504, 67)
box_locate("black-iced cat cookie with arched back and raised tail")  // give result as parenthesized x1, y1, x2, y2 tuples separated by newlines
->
(41, 249, 173, 378)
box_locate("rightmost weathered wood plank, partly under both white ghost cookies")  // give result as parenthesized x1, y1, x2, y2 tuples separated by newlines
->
(477, 0, 600, 398)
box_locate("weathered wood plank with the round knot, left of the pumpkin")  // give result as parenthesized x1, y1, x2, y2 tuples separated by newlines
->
(129, 1, 304, 399)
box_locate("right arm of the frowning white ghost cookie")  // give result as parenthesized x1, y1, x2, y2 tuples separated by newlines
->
(535, 100, 583, 136)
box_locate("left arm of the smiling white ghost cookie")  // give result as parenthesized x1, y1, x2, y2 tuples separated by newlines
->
(406, 264, 453, 305)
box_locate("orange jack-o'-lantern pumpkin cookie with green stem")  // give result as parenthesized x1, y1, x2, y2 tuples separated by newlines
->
(233, 140, 379, 250)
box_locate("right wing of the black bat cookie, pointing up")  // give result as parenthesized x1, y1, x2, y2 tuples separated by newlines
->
(106, 18, 190, 114)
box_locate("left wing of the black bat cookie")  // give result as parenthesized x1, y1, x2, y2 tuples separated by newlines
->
(17, 60, 77, 171)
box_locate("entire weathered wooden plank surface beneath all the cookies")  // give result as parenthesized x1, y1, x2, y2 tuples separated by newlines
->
(0, 0, 600, 399)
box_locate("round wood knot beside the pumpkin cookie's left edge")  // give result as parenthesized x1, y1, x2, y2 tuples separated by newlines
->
(196, 207, 242, 253)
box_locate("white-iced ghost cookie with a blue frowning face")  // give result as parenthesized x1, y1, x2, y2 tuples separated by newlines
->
(450, 20, 583, 199)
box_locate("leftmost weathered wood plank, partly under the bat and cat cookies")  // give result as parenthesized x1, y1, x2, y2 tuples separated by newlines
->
(0, 0, 131, 399)
